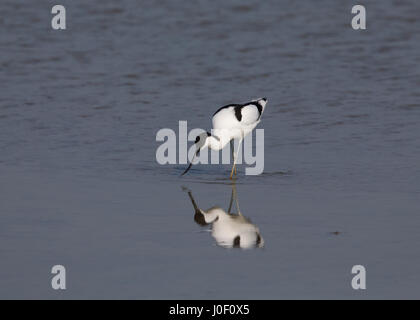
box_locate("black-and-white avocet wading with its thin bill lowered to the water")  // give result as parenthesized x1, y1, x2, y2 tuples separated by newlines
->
(182, 98, 267, 179)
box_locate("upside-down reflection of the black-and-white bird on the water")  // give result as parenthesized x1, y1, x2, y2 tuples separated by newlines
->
(184, 184, 264, 249)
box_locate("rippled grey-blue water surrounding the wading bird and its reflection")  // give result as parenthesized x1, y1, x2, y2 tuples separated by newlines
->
(0, 0, 420, 299)
